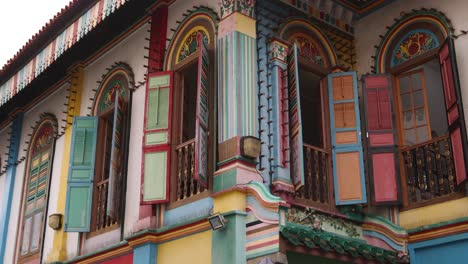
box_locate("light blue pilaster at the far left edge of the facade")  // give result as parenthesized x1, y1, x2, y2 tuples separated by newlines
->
(0, 113, 23, 263)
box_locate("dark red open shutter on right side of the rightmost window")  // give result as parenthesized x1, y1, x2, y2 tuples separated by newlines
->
(439, 37, 468, 185)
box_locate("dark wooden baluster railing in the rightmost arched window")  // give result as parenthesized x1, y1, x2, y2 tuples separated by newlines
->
(401, 136, 456, 203)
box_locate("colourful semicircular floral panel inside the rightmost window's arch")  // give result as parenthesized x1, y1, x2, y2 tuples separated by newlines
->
(391, 29, 440, 67)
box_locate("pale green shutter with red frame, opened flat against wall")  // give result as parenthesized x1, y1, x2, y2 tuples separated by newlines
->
(141, 71, 173, 204)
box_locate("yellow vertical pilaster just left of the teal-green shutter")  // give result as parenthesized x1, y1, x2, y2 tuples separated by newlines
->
(47, 65, 84, 262)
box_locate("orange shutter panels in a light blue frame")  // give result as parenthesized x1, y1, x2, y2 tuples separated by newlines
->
(328, 72, 367, 205)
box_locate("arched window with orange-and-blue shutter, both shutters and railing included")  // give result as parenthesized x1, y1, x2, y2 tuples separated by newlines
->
(273, 20, 367, 209)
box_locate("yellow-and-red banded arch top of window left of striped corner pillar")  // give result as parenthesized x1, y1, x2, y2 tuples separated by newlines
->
(164, 8, 219, 70)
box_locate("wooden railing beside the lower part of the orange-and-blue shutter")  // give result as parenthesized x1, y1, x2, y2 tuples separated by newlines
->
(296, 144, 330, 204)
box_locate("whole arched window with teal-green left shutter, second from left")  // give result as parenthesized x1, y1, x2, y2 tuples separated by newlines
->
(65, 63, 133, 232)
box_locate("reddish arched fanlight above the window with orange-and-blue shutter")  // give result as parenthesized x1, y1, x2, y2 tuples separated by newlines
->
(278, 19, 337, 68)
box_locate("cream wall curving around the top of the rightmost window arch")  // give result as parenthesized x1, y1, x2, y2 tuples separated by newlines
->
(355, 0, 468, 127)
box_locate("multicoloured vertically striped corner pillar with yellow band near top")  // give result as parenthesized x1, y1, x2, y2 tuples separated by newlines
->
(218, 0, 258, 143)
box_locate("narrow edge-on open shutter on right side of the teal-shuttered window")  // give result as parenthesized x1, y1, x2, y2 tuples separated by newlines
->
(106, 90, 124, 219)
